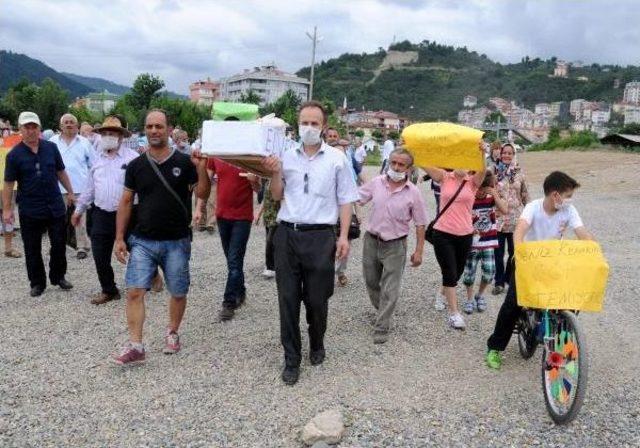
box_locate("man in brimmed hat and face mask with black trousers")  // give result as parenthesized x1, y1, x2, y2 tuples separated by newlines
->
(71, 116, 138, 305)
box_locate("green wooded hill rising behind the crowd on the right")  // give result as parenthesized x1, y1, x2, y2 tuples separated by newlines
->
(298, 41, 640, 120)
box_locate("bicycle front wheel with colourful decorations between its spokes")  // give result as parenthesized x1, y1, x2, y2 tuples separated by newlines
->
(542, 311, 589, 425)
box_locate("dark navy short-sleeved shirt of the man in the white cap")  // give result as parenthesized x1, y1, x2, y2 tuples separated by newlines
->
(4, 139, 66, 219)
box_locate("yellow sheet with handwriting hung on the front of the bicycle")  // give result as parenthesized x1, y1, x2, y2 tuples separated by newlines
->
(515, 240, 609, 311)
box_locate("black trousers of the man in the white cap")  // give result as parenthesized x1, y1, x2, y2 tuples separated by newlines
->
(20, 214, 67, 288)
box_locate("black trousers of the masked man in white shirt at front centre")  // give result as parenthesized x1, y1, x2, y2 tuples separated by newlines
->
(273, 225, 336, 367)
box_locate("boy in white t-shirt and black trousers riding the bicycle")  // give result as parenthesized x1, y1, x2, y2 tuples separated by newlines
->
(486, 171, 593, 369)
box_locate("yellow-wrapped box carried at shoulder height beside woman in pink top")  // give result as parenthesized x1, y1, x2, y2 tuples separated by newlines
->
(402, 123, 484, 171)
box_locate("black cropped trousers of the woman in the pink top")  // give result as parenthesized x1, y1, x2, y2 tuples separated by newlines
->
(433, 230, 473, 287)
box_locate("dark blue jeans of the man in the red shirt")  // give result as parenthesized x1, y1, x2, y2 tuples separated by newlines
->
(218, 218, 251, 308)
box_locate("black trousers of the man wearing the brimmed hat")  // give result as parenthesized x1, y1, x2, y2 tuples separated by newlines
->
(90, 207, 118, 295)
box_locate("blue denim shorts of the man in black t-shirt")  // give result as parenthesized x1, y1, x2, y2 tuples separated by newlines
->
(124, 235, 191, 297)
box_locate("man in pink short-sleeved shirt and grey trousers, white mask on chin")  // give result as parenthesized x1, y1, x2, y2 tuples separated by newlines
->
(359, 148, 427, 344)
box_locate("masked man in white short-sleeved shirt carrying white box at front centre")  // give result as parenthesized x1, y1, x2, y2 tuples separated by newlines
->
(264, 101, 358, 385)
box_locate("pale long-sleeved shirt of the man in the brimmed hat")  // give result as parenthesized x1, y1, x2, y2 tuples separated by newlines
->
(76, 145, 139, 213)
